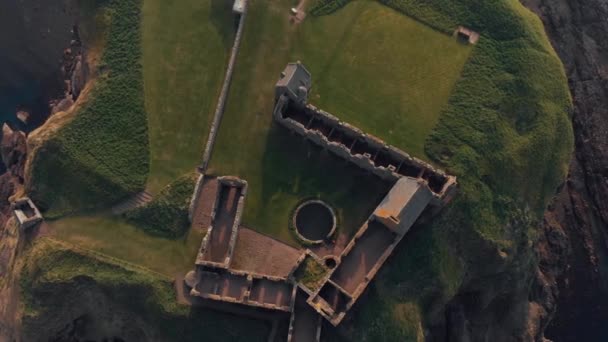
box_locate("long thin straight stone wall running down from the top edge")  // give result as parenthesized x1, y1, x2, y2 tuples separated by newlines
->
(199, 0, 248, 173)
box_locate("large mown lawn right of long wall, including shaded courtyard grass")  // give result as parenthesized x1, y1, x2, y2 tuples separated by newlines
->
(210, 0, 471, 242)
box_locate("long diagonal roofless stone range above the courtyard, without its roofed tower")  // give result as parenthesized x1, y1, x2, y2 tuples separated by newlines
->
(273, 95, 456, 206)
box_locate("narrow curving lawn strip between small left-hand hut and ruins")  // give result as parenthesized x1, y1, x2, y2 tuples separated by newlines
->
(48, 216, 203, 277)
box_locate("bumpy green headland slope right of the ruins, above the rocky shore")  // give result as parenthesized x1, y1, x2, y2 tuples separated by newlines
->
(356, 0, 572, 340)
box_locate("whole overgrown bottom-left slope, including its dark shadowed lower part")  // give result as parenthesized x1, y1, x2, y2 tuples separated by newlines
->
(21, 239, 270, 341)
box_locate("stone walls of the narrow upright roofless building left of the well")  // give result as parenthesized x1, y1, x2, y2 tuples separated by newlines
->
(196, 176, 248, 268)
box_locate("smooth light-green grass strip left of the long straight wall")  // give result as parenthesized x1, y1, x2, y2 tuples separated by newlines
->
(142, 0, 234, 193)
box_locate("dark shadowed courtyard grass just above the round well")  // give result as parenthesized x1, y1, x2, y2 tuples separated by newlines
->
(262, 124, 390, 235)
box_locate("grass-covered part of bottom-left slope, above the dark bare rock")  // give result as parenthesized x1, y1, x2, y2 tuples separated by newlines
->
(21, 240, 269, 341)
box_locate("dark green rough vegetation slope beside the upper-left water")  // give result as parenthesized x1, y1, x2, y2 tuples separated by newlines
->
(26, 0, 148, 216)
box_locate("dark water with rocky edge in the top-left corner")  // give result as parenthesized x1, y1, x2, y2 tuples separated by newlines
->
(0, 0, 88, 131)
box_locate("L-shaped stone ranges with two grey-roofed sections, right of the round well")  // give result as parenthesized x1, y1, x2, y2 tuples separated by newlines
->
(273, 62, 456, 326)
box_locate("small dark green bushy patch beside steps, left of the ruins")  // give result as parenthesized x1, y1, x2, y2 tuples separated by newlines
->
(125, 174, 197, 238)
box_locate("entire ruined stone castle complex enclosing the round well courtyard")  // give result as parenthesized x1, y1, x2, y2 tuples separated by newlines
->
(185, 62, 456, 342)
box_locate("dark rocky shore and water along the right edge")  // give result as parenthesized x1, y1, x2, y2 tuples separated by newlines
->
(524, 0, 608, 341)
